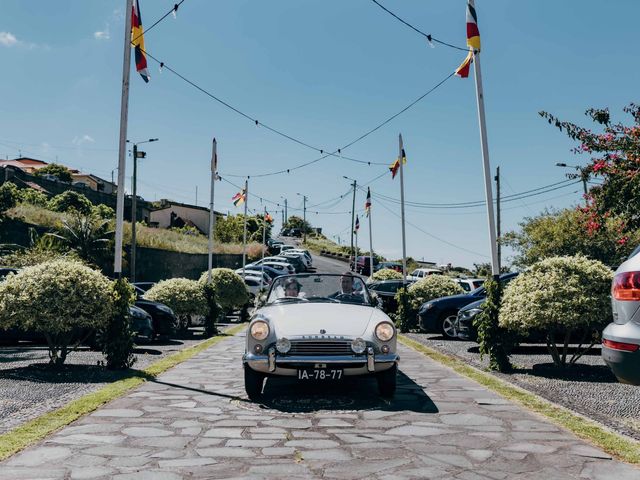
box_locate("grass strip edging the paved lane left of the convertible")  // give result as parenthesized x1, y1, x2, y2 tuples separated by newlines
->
(0, 325, 246, 461)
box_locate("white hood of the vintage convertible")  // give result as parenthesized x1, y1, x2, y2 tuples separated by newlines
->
(258, 302, 386, 338)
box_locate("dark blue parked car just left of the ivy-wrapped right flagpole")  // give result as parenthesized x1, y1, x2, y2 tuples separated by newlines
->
(418, 273, 518, 339)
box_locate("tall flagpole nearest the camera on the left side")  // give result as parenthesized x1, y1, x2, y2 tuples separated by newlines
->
(113, 0, 133, 278)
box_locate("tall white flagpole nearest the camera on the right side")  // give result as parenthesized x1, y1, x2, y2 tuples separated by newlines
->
(470, 51, 500, 280)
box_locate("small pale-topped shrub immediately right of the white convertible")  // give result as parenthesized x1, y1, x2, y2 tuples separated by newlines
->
(396, 276, 464, 332)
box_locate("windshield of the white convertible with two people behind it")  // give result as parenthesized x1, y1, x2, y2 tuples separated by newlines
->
(267, 274, 370, 305)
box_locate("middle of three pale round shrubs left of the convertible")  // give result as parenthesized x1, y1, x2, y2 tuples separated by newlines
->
(144, 278, 209, 331)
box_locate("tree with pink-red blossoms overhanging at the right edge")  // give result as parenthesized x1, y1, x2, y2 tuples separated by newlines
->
(540, 103, 640, 253)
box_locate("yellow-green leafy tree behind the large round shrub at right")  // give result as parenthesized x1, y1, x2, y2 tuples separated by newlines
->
(503, 209, 640, 268)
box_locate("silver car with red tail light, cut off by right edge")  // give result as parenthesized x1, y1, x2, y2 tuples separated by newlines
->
(602, 246, 640, 385)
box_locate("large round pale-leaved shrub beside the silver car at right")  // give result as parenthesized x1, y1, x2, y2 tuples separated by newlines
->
(499, 256, 613, 366)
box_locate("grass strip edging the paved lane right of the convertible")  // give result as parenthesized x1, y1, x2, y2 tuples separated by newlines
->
(399, 335, 640, 465)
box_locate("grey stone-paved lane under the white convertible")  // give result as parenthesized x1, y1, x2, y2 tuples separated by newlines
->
(0, 336, 640, 480)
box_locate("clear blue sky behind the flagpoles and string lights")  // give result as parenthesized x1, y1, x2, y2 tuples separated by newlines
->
(0, 0, 640, 266)
